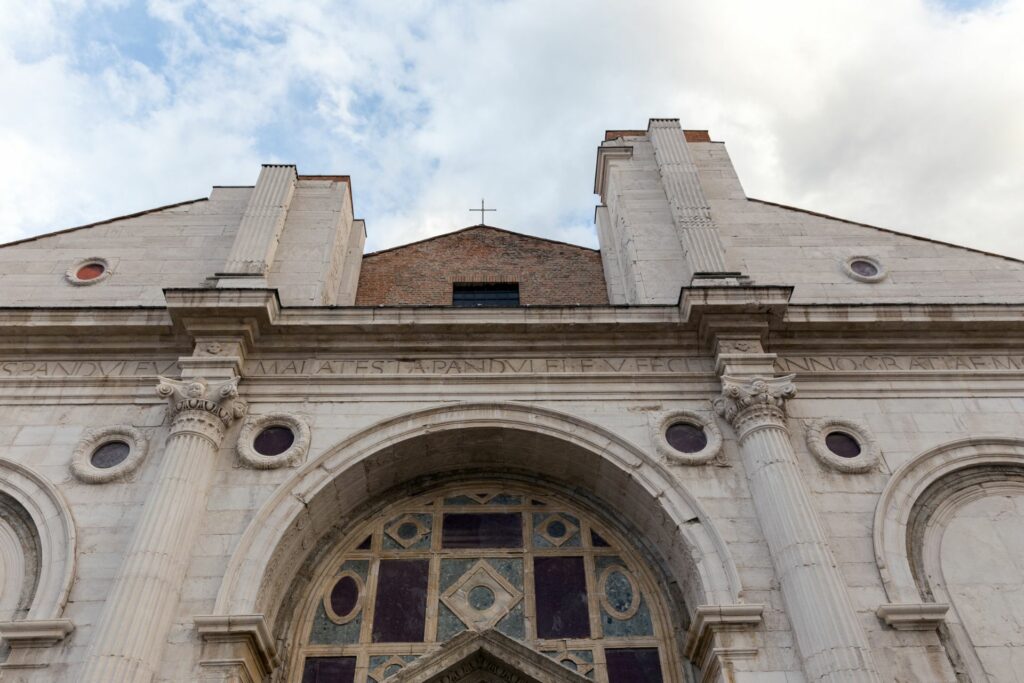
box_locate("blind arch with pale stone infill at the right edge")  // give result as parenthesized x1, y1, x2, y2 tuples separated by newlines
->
(874, 437, 1024, 681)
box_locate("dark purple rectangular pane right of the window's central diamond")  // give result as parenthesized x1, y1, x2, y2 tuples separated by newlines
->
(534, 557, 590, 639)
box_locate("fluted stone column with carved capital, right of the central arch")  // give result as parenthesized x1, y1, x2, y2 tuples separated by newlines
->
(715, 375, 880, 683)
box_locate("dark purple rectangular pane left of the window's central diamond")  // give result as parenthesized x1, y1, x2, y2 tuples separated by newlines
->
(374, 560, 430, 643)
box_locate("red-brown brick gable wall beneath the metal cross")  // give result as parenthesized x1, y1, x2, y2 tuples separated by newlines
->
(355, 226, 608, 306)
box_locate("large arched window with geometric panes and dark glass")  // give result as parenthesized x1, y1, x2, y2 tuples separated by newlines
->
(288, 483, 682, 683)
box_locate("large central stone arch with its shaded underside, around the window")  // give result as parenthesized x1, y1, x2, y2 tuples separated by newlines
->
(215, 403, 741, 651)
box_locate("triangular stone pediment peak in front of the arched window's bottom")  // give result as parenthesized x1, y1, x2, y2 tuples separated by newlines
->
(388, 630, 589, 683)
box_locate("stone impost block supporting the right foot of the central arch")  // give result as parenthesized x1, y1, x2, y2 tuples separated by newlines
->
(683, 604, 765, 683)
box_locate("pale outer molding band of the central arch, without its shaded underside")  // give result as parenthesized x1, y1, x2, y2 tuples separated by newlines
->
(214, 402, 741, 621)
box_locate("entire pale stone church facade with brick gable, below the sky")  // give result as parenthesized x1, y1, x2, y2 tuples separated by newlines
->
(0, 119, 1024, 683)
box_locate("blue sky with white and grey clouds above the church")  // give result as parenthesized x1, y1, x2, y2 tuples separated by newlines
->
(0, 0, 1024, 257)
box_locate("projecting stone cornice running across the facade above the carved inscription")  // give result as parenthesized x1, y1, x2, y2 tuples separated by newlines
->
(0, 296, 1024, 353)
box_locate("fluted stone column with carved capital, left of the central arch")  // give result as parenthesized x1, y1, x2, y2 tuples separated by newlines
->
(79, 377, 246, 683)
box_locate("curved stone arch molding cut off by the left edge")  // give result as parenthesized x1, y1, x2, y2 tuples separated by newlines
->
(0, 458, 78, 623)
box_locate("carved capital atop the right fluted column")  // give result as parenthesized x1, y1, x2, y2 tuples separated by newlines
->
(714, 375, 797, 437)
